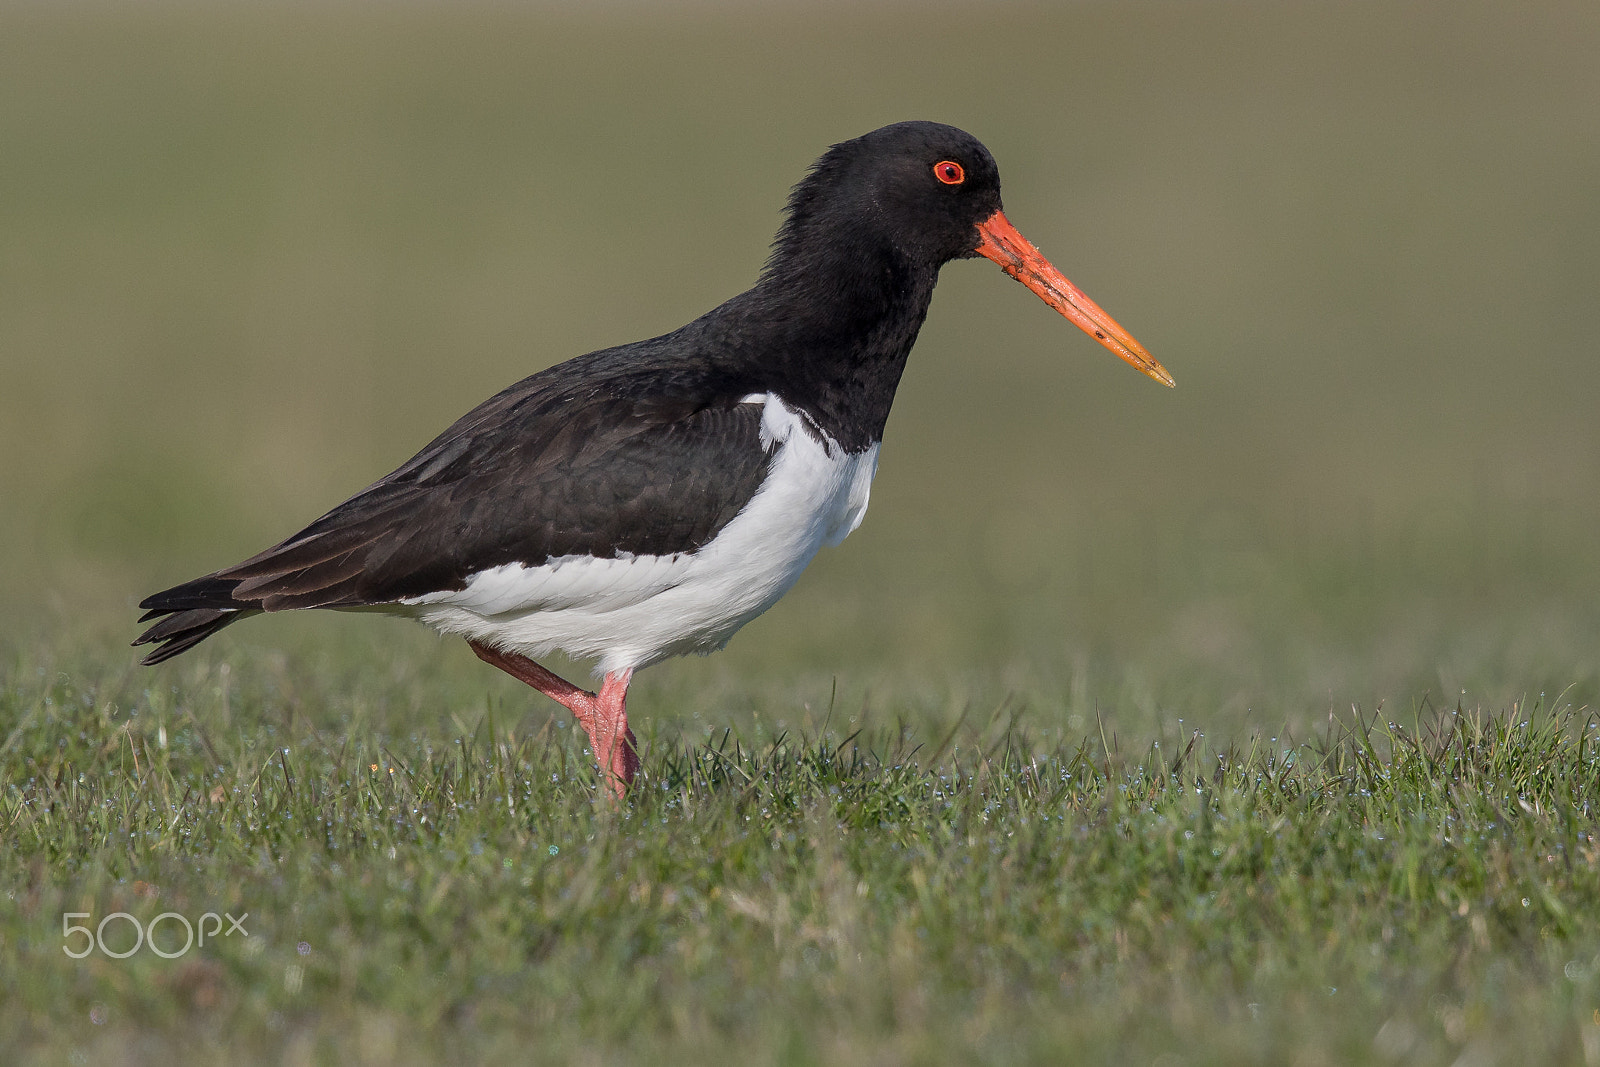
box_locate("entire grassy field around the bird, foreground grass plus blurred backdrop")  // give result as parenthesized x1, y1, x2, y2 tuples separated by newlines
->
(0, 2, 1600, 1067)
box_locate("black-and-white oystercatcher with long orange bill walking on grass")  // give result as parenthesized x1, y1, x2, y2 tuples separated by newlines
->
(133, 122, 1173, 798)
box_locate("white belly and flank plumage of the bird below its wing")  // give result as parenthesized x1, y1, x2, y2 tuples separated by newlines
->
(392, 394, 878, 672)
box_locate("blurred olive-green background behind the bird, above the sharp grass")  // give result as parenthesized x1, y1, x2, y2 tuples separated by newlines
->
(0, 0, 1600, 734)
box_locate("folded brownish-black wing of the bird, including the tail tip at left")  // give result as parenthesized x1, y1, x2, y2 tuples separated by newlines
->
(134, 354, 770, 664)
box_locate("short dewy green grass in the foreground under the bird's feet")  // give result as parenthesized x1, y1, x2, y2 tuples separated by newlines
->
(0, 655, 1600, 1062)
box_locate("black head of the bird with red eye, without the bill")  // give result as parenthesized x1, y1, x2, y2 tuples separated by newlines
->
(773, 122, 1000, 267)
